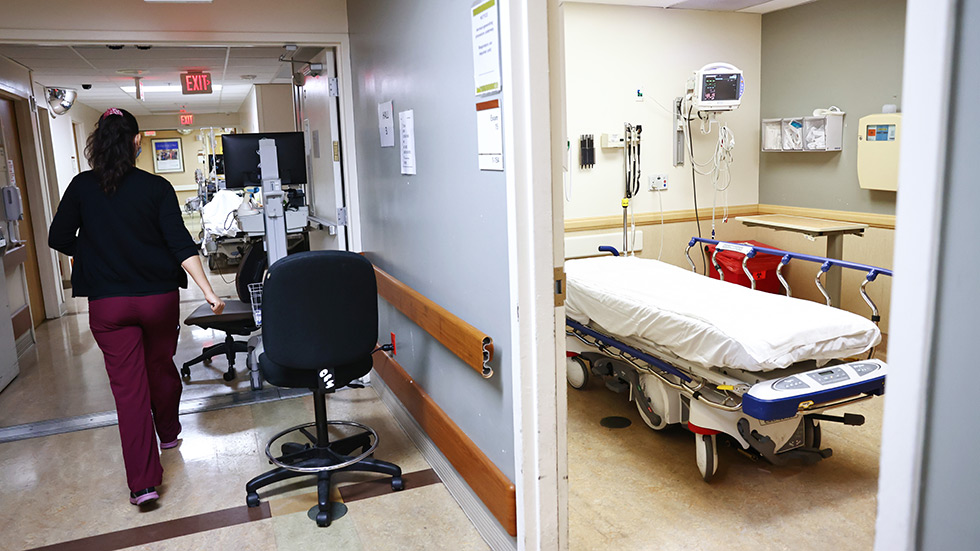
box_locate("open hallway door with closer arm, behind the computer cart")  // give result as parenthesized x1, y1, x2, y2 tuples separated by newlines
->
(294, 48, 350, 250)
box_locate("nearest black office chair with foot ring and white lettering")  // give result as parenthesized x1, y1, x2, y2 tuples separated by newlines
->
(245, 251, 404, 526)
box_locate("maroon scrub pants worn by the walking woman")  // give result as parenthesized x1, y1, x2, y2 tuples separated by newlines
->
(89, 291, 181, 492)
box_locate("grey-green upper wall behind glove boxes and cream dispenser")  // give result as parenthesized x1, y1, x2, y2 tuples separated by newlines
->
(760, 0, 905, 214)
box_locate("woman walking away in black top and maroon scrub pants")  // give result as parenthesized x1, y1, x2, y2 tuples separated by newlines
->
(48, 108, 224, 505)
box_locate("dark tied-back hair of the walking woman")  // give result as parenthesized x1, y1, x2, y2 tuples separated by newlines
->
(85, 108, 140, 195)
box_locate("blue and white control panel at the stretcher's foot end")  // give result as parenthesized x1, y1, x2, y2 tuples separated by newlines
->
(742, 360, 887, 421)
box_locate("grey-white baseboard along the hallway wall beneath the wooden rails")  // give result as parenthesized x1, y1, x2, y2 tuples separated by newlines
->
(371, 373, 517, 551)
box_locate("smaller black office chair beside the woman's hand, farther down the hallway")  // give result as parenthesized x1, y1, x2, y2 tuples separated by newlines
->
(180, 245, 267, 382)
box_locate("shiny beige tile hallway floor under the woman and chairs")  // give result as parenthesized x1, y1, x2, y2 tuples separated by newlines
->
(0, 274, 487, 551)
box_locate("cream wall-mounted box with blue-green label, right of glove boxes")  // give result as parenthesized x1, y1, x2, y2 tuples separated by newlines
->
(857, 113, 902, 191)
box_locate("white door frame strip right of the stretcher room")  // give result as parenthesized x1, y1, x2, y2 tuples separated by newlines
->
(875, 0, 958, 551)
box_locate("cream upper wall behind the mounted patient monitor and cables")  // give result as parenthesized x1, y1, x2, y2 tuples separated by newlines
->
(564, 3, 762, 220)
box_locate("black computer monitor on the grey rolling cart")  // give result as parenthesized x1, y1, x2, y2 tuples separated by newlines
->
(221, 132, 306, 189)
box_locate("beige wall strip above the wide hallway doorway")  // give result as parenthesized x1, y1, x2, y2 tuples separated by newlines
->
(0, 0, 347, 41)
